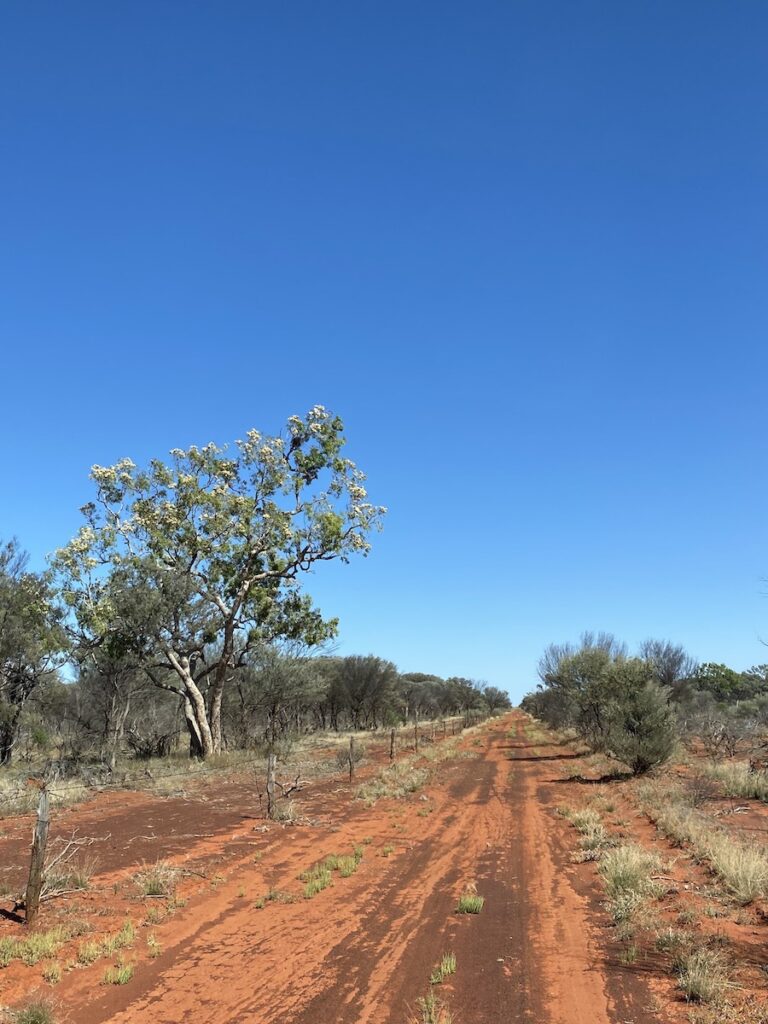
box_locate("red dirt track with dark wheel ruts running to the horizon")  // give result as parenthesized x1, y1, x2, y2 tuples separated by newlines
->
(3, 715, 659, 1024)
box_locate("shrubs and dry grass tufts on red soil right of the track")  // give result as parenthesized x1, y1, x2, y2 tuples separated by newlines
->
(540, 636, 768, 1024)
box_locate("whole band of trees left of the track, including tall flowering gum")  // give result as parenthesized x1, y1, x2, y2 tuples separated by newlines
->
(0, 407, 509, 771)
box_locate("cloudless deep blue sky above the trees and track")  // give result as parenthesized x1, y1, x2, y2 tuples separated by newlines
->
(0, 0, 768, 696)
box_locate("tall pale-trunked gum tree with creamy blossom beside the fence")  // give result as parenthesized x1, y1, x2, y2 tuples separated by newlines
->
(54, 406, 386, 758)
